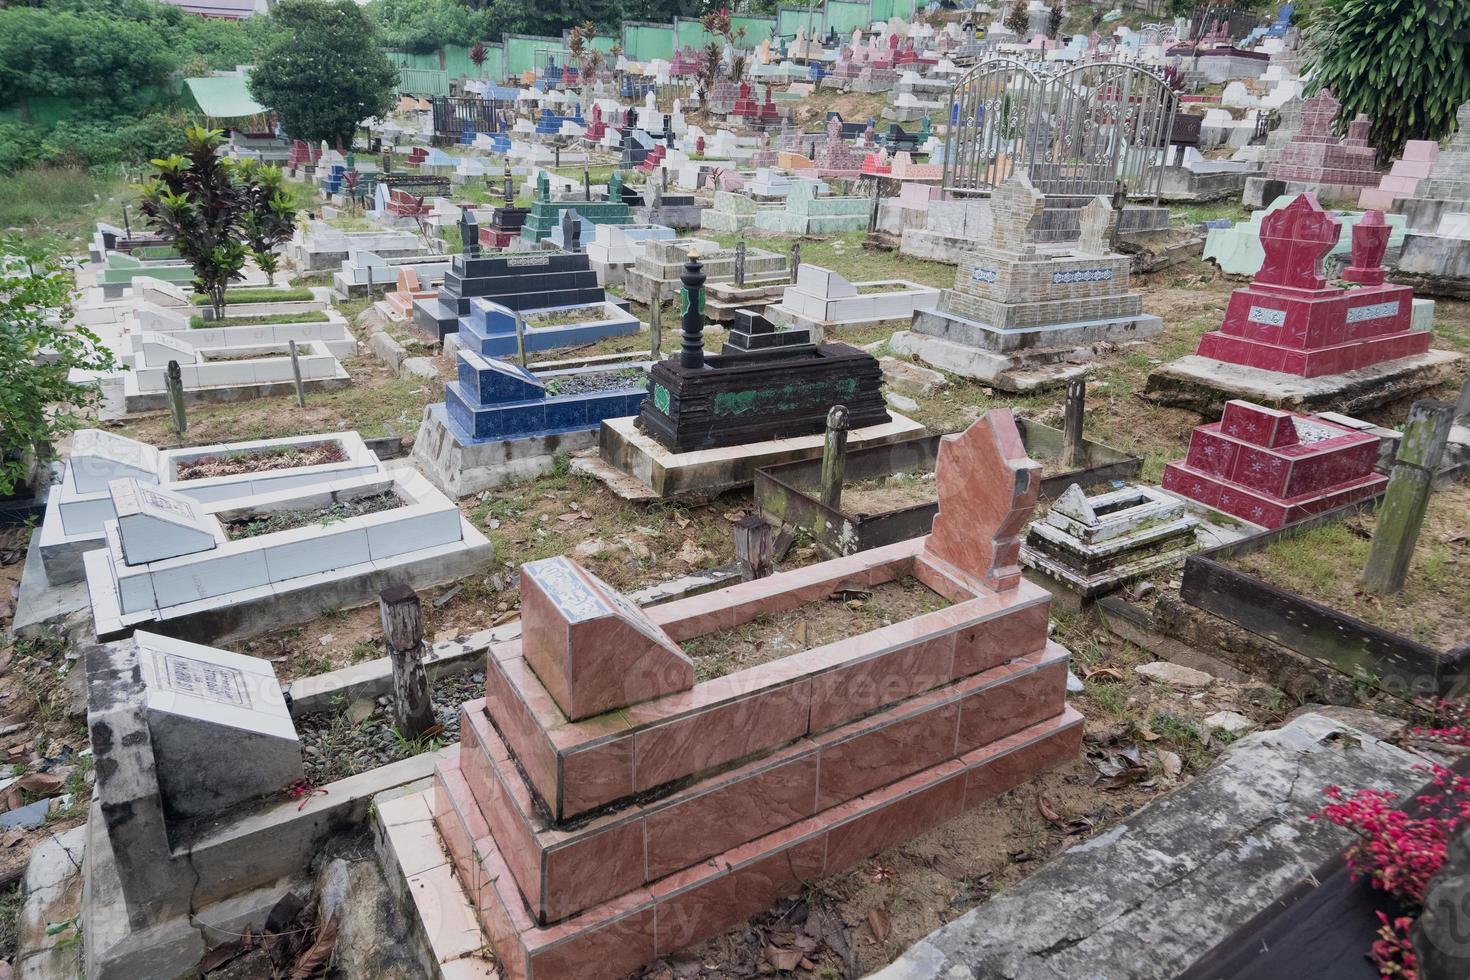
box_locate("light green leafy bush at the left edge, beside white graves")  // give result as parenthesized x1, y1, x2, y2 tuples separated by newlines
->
(0, 238, 116, 495)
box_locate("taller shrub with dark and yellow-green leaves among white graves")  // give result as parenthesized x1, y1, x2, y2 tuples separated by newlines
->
(138, 126, 250, 316)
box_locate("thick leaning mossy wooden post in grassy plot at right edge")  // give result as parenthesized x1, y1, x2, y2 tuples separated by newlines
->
(1363, 400, 1454, 594)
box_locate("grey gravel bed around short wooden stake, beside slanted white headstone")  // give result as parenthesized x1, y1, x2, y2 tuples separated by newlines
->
(295, 671, 485, 786)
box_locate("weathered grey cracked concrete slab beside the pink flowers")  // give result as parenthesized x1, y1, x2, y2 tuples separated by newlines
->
(872, 714, 1427, 980)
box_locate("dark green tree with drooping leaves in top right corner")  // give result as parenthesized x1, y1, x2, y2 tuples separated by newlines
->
(1304, 0, 1470, 159)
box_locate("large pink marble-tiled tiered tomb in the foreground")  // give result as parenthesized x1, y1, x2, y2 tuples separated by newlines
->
(408, 411, 1082, 980)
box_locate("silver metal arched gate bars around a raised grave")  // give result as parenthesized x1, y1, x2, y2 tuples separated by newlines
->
(944, 59, 1177, 198)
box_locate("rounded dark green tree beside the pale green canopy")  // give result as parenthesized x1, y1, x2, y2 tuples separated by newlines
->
(250, 0, 398, 147)
